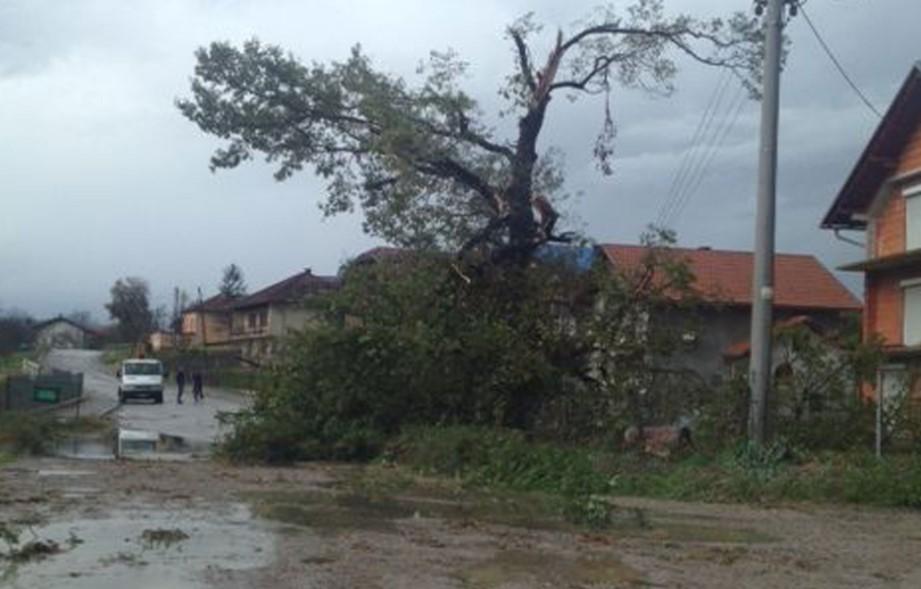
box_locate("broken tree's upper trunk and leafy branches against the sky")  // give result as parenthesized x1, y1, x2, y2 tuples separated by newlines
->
(177, 0, 760, 254)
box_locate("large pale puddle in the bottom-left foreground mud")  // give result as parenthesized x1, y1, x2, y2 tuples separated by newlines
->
(0, 505, 274, 589)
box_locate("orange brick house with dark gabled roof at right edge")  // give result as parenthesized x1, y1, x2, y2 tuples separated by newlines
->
(822, 63, 921, 397)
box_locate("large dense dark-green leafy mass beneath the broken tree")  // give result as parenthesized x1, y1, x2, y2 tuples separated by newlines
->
(217, 233, 687, 460)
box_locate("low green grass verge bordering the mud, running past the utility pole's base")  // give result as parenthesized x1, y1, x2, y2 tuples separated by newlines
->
(391, 428, 921, 510)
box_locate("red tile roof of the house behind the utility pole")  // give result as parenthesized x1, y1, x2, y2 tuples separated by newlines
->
(600, 244, 862, 311)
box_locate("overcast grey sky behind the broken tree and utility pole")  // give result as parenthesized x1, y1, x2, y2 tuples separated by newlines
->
(0, 0, 921, 320)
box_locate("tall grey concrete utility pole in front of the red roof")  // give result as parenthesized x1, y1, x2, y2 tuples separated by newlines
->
(748, 0, 796, 446)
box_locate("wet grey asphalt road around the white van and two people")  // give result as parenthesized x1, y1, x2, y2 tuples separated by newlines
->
(45, 350, 245, 448)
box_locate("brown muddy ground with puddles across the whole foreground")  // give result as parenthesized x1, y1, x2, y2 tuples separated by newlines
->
(0, 458, 921, 589)
